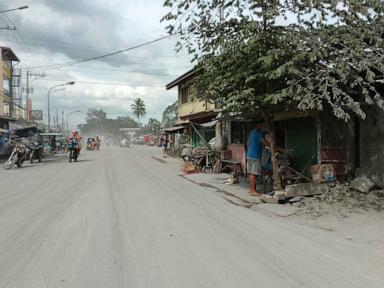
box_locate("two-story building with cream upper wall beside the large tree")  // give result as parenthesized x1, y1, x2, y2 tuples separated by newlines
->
(166, 69, 218, 147)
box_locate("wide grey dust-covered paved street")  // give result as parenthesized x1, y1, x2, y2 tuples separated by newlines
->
(0, 146, 384, 288)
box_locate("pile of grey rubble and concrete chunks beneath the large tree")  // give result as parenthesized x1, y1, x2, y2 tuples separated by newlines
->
(261, 176, 384, 216)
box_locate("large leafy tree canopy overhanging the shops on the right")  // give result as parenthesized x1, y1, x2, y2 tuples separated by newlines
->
(163, 0, 384, 120)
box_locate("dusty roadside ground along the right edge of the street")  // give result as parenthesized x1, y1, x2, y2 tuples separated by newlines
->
(185, 169, 384, 250)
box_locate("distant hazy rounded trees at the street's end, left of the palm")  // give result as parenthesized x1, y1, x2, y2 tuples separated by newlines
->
(79, 108, 139, 136)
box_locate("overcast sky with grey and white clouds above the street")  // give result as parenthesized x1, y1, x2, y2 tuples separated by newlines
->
(0, 0, 192, 124)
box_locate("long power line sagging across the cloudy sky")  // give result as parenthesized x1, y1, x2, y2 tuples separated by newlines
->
(21, 35, 178, 69)
